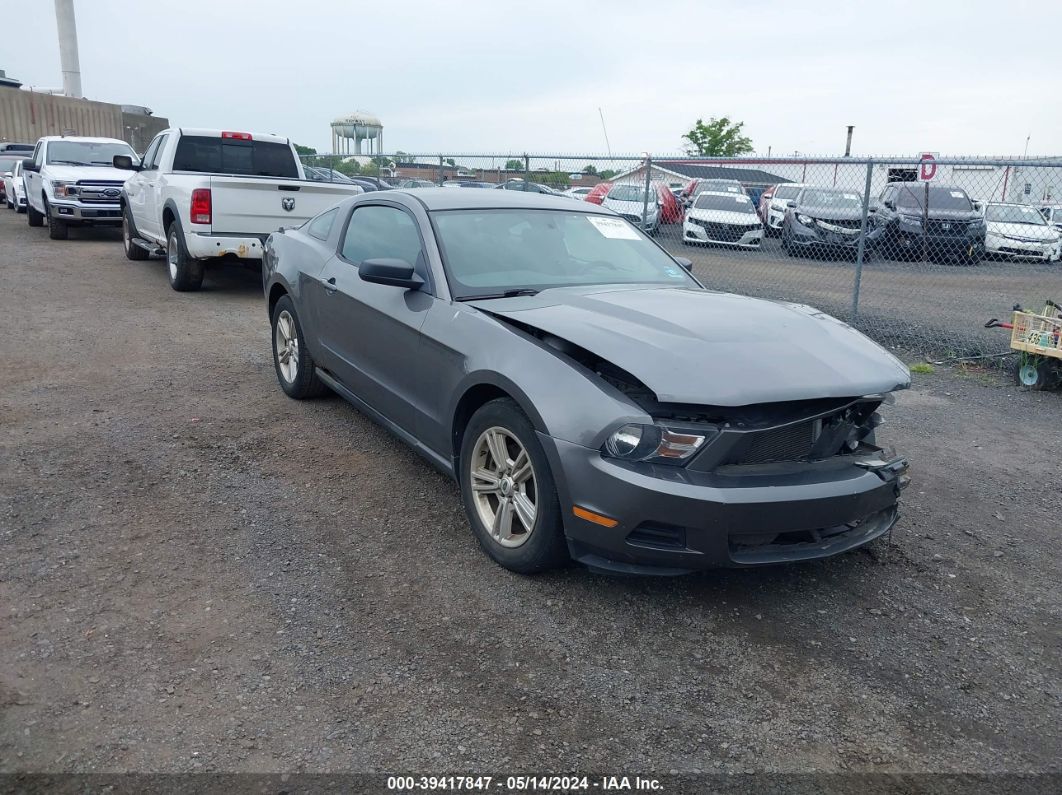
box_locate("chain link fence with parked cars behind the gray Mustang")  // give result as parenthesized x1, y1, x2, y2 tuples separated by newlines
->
(293, 152, 1062, 358)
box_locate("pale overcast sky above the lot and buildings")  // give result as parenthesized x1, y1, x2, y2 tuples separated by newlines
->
(0, 0, 1062, 155)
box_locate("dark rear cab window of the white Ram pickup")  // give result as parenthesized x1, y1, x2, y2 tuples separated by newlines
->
(173, 135, 298, 179)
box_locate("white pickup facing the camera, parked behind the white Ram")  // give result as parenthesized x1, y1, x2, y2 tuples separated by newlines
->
(22, 136, 140, 240)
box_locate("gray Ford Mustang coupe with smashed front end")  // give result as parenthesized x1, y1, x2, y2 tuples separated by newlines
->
(262, 188, 910, 574)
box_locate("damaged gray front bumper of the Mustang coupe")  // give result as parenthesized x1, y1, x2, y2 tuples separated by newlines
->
(539, 434, 906, 574)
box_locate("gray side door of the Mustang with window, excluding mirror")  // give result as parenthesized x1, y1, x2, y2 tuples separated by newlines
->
(311, 203, 433, 433)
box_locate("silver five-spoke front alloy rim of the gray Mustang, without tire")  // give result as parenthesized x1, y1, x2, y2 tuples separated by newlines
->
(468, 426, 538, 549)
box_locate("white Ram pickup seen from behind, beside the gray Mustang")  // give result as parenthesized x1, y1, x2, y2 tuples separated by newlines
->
(114, 128, 362, 291)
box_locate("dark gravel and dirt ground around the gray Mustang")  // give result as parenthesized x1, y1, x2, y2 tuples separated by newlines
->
(0, 211, 1062, 773)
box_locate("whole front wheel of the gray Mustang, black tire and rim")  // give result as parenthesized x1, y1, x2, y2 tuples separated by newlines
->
(459, 398, 568, 574)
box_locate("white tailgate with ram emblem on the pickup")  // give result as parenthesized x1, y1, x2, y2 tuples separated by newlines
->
(204, 176, 358, 236)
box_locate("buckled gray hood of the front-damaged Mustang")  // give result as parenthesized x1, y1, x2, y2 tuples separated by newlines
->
(472, 286, 910, 405)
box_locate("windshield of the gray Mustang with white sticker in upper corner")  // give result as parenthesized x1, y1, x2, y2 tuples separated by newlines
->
(432, 209, 697, 298)
